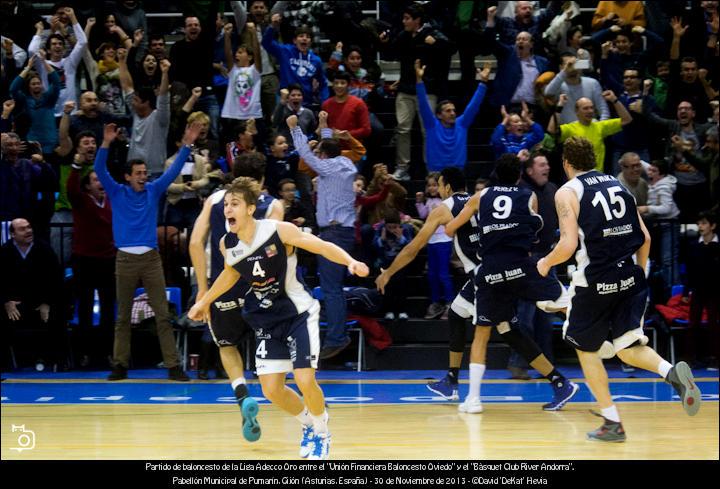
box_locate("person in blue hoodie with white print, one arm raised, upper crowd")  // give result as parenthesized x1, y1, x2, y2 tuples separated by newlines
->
(262, 14, 330, 106)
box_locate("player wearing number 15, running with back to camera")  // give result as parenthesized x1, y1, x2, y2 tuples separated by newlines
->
(537, 137, 701, 442)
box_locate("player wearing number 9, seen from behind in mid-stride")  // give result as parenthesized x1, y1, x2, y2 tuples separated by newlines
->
(445, 154, 578, 411)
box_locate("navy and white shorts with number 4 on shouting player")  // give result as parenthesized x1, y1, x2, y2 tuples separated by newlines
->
(255, 301, 320, 375)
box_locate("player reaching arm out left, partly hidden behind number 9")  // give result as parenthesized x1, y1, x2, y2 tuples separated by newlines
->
(375, 167, 480, 401)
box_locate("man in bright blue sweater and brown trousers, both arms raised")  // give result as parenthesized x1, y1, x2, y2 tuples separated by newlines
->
(95, 123, 202, 381)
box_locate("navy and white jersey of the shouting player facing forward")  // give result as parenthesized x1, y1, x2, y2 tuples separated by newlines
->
(223, 219, 314, 329)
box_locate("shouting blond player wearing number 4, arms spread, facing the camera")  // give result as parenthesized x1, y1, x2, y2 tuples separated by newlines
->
(188, 178, 368, 459)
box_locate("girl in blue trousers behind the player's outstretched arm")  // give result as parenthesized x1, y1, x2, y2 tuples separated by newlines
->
(415, 172, 455, 319)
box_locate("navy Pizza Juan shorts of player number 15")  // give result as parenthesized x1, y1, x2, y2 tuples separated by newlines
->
(563, 260, 648, 352)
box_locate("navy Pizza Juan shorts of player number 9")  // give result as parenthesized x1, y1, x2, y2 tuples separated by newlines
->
(475, 256, 569, 326)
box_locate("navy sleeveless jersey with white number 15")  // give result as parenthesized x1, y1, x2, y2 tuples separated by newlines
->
(563, 170, 645, 287)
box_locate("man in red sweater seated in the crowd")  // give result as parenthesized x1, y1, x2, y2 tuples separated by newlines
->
(322, 71, 370, 140)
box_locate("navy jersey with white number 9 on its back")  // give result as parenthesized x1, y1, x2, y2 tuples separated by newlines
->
(477, 186, 543, 258)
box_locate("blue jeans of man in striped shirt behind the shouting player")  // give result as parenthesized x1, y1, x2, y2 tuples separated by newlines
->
(318, 226, 355, 348)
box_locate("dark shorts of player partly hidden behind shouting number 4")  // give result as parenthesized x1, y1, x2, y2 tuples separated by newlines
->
(208, 282, 251, 346)
